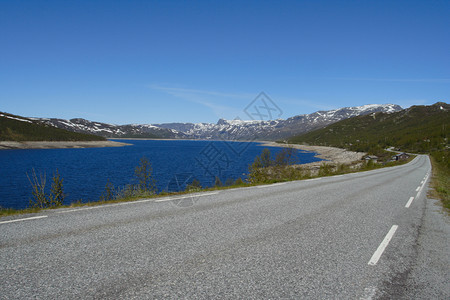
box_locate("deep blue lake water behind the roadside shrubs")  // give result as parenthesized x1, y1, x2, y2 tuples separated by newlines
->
(0, 140, 320, 209)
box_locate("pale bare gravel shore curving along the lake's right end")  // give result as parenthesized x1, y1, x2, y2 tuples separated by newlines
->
(256, 142, 366, 166)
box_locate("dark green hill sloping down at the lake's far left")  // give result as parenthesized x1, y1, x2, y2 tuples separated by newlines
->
(0, 112, 106, 142)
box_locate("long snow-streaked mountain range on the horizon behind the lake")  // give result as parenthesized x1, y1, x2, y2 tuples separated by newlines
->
(35, 104, 402, 140)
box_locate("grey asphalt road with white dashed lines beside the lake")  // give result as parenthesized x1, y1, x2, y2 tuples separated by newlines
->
(0, 156, 450, 299)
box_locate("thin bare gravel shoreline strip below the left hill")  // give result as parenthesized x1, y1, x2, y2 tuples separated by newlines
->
(0, 141, 130, 150)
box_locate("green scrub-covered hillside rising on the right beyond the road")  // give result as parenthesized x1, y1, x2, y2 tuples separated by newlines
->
(288, 102, 450, 153)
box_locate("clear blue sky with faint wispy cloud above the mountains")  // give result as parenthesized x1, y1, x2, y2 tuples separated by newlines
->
(0, 0, 450, 124)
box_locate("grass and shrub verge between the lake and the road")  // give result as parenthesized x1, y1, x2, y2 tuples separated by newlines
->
(0, 152, 414, 217)
